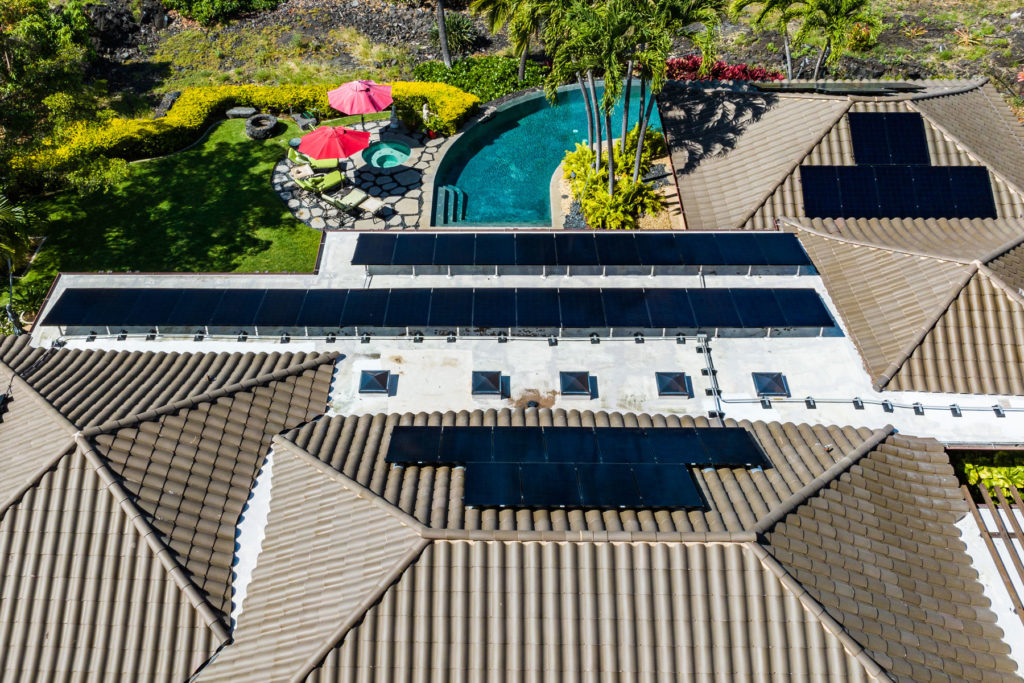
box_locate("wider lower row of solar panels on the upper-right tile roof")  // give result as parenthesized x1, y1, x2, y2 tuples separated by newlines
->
(800, 166, 996, 218)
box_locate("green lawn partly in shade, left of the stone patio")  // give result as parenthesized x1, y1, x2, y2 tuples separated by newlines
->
(24, 117, 323, 285)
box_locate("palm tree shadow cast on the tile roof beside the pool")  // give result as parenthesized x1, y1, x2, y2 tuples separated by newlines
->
(658, 82, 778, 175)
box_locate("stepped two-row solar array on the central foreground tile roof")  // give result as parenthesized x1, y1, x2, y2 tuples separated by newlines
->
(385, 426, 768, 508)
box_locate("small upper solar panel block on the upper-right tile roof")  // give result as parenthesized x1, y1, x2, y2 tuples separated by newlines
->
(847, 112, 931, 166)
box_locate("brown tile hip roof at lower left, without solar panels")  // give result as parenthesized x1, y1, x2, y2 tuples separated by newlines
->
(0, 339, 336, 681)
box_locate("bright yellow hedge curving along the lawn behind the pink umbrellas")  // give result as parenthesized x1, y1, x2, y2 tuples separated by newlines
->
(10, 82, 479, 185)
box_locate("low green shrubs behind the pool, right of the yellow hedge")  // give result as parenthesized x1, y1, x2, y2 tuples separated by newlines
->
(413, 56, 548, 102)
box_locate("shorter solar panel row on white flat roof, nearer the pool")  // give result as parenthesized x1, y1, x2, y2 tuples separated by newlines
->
(352, 231, 811, 266)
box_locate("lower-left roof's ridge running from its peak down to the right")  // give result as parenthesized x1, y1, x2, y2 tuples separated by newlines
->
(75, 433, 231, 643)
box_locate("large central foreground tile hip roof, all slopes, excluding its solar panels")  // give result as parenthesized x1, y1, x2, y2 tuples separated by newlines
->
(192, 410, 1014, 683)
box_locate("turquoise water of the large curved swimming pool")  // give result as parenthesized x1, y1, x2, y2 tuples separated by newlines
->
(434, 82, 662, 226)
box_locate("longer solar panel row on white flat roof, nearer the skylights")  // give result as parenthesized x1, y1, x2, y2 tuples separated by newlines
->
(42, 288, 835, 334)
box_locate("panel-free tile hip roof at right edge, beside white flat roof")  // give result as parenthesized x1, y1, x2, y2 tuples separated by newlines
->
(781, 218, 1024, 395)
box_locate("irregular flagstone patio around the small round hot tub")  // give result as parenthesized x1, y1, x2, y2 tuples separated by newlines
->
(270, 121, 444, 230)
